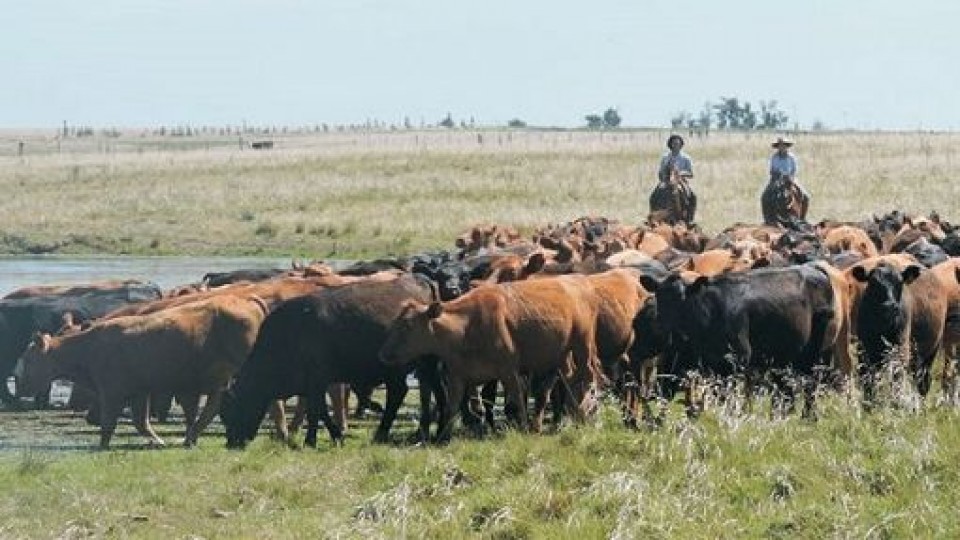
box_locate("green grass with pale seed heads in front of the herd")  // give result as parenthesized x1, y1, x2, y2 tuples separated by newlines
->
(0, 395, 960, 538)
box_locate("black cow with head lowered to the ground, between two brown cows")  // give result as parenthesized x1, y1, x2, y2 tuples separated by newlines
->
(220, 275, 435, 448)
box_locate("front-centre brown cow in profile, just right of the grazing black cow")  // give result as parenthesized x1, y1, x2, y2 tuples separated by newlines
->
(380, 278, 598, 440)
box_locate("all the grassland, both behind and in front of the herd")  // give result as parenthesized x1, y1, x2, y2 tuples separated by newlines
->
(0, 132, 960, 539)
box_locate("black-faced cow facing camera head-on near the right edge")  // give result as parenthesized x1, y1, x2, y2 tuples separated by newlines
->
(851, 263, 948, 404)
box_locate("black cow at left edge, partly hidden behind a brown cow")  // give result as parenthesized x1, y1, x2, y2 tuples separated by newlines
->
(0, 283, 163, 404)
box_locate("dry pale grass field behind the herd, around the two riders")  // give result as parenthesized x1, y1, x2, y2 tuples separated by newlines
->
(0, 131, 960, 257)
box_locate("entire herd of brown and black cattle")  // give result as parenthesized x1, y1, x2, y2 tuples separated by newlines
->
(0, 211, 960, 448)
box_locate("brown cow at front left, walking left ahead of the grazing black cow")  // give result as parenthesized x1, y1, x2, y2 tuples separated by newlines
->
(17, 295, 267, 448)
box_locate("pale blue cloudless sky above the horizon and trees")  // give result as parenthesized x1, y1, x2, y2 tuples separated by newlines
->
(0, 0, 960, 129)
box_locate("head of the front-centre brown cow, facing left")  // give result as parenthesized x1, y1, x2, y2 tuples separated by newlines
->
(380, 300, 443, 366)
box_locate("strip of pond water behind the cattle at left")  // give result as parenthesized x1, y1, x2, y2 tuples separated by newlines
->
(0, 255, 316, 296)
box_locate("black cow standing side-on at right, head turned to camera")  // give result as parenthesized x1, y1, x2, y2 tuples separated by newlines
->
(641, 265, 836, 416)
